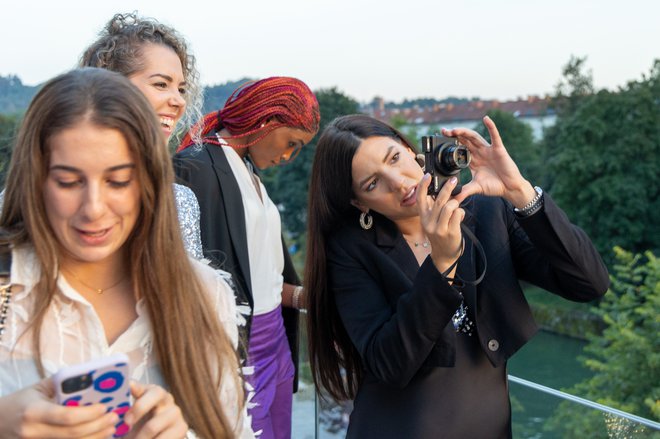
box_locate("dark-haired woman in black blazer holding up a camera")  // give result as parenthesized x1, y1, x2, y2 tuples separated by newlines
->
(305, 115, 609, 439)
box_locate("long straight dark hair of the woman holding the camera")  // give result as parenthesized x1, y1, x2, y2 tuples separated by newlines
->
(304, 114, 416, 401)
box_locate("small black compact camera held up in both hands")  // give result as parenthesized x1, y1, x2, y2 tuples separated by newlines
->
(422, 136, 471, 195)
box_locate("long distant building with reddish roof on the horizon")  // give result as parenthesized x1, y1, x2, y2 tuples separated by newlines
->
(362, 96, 556, 139)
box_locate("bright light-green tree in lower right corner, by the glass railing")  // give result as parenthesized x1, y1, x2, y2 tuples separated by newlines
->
(548, 247, 660, 438)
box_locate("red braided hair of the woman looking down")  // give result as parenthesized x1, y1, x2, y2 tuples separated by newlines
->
(177, 76, 320, 152)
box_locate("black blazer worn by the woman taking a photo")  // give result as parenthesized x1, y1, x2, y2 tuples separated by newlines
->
(327, 194, 609, 438)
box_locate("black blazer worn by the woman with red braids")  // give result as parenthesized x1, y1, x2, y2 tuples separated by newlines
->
(173, 139, 300, 388)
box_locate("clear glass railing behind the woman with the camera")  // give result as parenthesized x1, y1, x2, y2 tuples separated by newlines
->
(293, 375, 660, 439)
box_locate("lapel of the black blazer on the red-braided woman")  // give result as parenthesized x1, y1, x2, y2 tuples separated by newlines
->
(206, 145, 252, 296)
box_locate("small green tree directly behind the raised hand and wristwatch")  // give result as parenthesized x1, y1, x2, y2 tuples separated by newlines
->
(476, 109, 541, 183)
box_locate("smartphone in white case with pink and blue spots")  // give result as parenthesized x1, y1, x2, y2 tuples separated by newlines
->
(53, 353, 131, 437)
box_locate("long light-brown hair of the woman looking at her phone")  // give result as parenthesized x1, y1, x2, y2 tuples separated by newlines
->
(0, 68, 242, 437)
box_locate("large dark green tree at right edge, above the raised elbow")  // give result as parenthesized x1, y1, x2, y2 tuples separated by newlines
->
(543, 60, 660, 263)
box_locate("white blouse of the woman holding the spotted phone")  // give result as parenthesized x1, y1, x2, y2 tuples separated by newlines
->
(0, 246, 254, 439)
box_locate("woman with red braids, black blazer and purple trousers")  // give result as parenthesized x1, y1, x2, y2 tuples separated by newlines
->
(174, 77, 320, 439)
